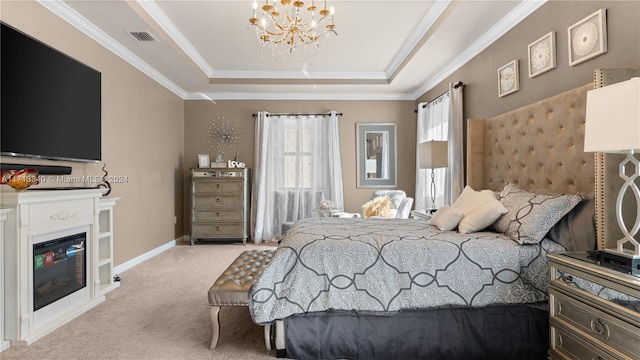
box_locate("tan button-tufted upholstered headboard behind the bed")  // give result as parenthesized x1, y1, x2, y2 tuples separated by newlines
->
(466, 84, 595, 194)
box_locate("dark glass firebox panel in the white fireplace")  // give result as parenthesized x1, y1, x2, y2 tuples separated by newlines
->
(33, 233, 87, 311)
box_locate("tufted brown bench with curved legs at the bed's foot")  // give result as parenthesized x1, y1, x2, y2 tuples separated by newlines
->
(209, 250, 275, 350)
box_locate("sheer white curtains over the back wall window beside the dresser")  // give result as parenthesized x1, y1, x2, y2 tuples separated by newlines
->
(251, 111, 343, 243)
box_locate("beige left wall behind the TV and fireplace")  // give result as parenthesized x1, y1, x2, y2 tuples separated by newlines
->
(0, 0, 185, 265)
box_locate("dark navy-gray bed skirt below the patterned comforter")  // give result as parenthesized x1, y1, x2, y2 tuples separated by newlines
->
(279, 305, 549, 360)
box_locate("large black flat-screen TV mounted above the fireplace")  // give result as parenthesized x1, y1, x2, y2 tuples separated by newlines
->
(0, 23, 101, 162)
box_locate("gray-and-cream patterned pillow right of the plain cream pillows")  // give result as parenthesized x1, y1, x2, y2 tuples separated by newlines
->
(493, 184, 582, 244)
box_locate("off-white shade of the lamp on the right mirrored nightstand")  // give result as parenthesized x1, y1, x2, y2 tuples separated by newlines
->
(584, 77, 640, 153)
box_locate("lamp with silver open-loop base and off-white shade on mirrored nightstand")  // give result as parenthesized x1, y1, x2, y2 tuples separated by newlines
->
(584, 77, 640, 273)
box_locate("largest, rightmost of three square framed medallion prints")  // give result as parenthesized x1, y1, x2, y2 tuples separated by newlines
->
(567, 9, 607, 66)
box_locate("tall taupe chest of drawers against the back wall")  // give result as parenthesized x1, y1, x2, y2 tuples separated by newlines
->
(191, 168, 251, 245)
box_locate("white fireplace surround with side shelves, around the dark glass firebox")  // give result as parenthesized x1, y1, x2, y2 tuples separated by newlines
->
(0, 189, 118, 346)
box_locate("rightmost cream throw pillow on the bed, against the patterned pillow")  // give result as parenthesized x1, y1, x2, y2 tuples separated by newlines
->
(453, 186, 508, 234)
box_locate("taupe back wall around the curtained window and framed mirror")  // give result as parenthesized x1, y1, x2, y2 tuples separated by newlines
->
(183, 100, 416, 228)
